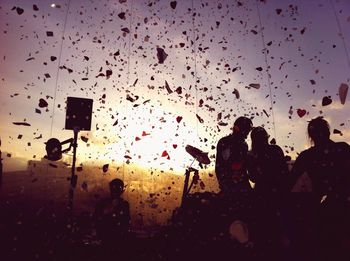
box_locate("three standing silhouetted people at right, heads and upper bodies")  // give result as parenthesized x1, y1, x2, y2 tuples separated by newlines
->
(215, 117, 350, 195)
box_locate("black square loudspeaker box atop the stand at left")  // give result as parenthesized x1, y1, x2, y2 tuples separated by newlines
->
(65, 97, 93, 131)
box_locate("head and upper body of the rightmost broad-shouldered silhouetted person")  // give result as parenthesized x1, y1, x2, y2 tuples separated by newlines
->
(292, 117, 350, 200)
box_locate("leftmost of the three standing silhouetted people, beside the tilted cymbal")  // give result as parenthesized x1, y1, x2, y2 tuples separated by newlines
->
(215, 117, 253, 193)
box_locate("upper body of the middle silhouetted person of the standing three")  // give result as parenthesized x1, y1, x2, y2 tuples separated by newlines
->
(247, 127, 287, 193)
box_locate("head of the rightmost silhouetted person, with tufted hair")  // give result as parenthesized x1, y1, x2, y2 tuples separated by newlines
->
(307, 116, 330, 145)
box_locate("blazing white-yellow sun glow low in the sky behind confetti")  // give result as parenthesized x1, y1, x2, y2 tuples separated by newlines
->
(73, 103, 211, 172)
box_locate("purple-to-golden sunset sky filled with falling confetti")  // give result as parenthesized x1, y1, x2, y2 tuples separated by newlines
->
(0, 0, 350, 172)
